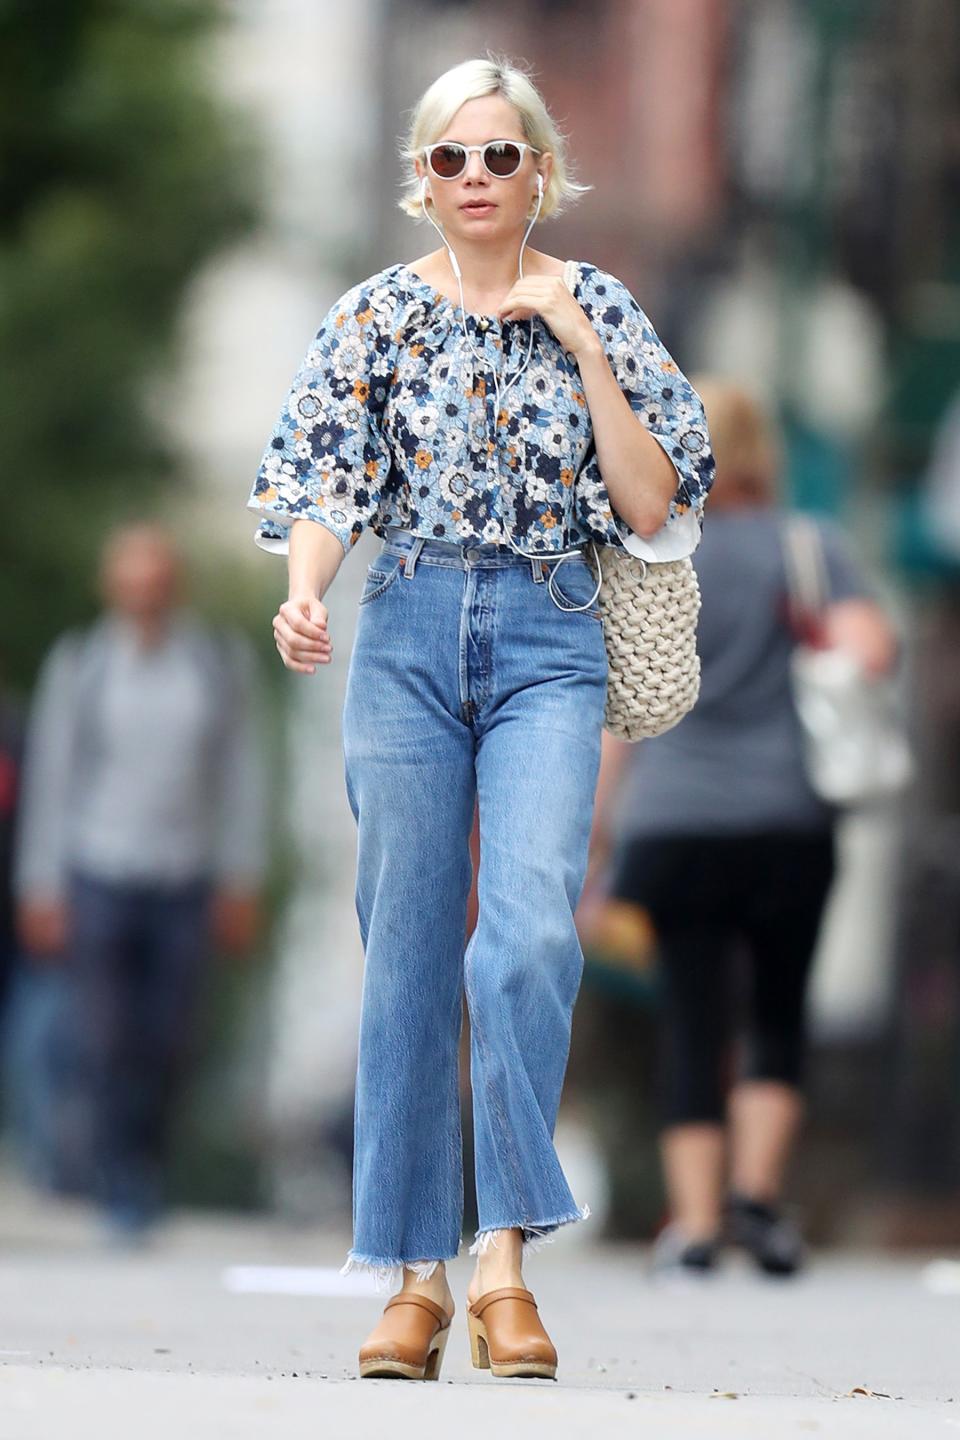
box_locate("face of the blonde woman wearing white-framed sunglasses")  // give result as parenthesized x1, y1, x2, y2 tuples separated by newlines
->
(416, 95, 553, 249)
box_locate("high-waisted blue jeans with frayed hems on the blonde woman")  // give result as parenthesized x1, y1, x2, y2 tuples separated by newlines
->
(343, 527, 607, 1286)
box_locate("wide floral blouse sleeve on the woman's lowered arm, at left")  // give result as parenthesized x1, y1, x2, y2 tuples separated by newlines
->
(248, 276, 396, 554)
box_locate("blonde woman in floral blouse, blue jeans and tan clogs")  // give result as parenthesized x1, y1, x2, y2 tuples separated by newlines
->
(249, 59, 712, 1380)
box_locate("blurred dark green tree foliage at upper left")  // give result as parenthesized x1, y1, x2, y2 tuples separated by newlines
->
(0, 0, 256, 685)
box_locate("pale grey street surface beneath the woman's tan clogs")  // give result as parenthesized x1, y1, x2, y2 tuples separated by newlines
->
(0, 1178, 960, 1440)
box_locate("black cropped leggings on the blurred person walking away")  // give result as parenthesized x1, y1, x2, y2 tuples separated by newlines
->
(612, 831, 835, 1125)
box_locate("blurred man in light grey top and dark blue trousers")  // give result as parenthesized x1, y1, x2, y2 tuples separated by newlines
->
(14, 521, 265, 1237)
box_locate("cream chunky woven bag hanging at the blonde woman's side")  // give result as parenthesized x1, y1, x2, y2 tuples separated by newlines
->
(563, 261, 699, 740)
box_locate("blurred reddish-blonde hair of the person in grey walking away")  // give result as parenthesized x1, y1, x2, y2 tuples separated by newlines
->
(688, 374, 783, 508)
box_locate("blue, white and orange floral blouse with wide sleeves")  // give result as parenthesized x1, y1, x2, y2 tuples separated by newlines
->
(248, 262, 714, 560)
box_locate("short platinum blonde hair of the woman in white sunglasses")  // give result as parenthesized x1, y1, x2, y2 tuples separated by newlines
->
(399, 55, 593, 220)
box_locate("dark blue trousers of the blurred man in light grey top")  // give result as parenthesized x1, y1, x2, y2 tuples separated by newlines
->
(69, 870, 212, 1227)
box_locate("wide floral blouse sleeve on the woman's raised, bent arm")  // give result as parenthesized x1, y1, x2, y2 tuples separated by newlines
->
(576, 269, 715, 560)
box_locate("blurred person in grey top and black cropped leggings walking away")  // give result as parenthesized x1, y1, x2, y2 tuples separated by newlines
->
(594, 377, 897, 1273)
